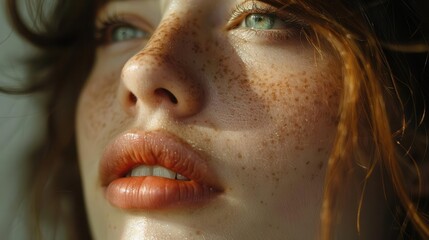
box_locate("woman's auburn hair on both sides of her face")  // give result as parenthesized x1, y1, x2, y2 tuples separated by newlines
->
(1, 0, 429, 239)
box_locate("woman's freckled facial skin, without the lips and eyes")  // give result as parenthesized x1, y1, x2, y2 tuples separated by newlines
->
(77, 0, 342, 239)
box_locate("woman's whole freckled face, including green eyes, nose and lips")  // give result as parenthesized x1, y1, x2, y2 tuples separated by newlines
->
(77, 0, 342, 239)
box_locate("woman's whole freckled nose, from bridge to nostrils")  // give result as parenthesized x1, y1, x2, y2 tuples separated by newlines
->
(120, 16, 204, 118)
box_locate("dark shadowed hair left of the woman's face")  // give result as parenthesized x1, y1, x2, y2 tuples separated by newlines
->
(0, 0, 102, 239)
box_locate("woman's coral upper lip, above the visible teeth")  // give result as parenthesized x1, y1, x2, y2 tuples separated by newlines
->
(100, 130, 221, 191)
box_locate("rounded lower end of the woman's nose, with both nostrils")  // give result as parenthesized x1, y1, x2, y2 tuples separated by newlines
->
(122, 55, 204, 118)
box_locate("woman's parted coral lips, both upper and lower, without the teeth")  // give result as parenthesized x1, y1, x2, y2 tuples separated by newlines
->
(100, 131, 221, 209)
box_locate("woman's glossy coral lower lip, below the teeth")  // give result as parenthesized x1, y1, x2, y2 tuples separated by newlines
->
(105, 176, 217, 209)
